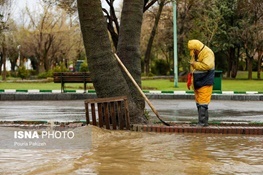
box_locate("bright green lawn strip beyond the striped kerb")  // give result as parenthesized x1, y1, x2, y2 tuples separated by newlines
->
(0, 79, 263, 92)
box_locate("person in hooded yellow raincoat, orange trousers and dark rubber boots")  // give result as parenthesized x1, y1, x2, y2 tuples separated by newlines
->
(187, 40, 215, 126)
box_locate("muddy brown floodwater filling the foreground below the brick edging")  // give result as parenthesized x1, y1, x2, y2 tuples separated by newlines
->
(0, 126, 263, 175)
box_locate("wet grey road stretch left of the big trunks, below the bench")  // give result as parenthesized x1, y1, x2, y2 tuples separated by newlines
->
(0, 101, 85, 121)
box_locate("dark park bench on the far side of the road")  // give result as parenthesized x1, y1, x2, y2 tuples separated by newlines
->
(53, 72, 92, 93)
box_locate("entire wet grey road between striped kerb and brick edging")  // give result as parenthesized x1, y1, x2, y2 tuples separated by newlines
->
(0, 99, 263, 122)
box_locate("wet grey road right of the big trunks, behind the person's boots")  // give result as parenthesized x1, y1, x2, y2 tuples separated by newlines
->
(147, 100, 263, 122)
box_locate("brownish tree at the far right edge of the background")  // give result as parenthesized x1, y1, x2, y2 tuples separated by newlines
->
(238, 0, 263, 79)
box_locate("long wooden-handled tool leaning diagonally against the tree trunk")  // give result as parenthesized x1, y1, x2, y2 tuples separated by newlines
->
(114, 53, 170, 126)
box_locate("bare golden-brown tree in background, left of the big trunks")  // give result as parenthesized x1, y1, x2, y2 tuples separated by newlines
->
(19, 0, 84, 72)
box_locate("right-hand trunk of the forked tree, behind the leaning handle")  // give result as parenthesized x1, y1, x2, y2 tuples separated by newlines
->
(117, 0, 145, 123)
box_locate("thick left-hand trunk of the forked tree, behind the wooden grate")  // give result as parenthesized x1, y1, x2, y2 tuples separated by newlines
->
(78, 0, 147, 123)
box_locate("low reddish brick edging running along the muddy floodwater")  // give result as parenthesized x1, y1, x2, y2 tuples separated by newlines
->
(0, 122, 263, 135)
